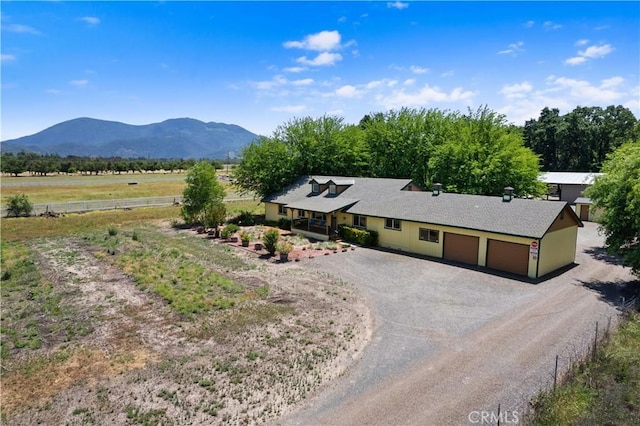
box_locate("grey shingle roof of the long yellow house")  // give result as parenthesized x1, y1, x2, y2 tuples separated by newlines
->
(262, 176, 582, 238)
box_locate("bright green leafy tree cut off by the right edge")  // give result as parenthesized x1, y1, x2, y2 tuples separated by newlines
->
(585, 141, 640, 277)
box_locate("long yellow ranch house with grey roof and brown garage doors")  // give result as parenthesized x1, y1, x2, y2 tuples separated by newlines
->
(262, 176, 583, 278)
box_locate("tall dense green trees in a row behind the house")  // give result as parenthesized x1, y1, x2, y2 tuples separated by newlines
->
(234, 106, 639, 196)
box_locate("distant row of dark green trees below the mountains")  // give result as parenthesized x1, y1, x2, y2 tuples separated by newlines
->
(0, 152, 222, 176)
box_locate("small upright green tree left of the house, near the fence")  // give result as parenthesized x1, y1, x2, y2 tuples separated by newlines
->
(180, 161, 225, 223)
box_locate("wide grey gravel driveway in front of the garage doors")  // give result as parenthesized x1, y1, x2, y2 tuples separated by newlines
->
(279, 223, 633, 425)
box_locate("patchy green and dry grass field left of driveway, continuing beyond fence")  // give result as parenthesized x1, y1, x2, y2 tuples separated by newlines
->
(0, 181, 368, 425)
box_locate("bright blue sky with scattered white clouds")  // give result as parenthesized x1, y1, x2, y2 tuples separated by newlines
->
(0, 1, 640, 140)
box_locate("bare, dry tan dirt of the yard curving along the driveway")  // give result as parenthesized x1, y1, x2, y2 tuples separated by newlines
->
(2, 224, 371, 425)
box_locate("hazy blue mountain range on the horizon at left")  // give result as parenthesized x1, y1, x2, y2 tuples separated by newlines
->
(0, 118, 258, 159)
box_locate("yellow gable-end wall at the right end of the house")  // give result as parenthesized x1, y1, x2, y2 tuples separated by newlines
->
(538, 226, 578, 277)
